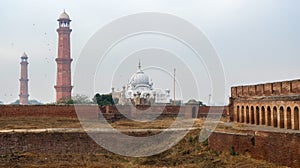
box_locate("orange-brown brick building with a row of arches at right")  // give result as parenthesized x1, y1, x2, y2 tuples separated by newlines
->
(229, 80, 300, 130)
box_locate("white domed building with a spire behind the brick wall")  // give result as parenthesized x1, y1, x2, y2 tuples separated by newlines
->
(111, 61, 170, 105)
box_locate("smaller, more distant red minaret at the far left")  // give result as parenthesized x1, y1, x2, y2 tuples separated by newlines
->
(19, 52, 29, 105)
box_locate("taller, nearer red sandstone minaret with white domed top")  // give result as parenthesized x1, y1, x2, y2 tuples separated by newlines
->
(54, 11, 73, 102)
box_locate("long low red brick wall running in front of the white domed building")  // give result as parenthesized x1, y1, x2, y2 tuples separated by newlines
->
(0, 105, 229, 121)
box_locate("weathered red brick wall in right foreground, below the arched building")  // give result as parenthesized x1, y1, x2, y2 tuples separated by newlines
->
(208, 131, 300, 167)
